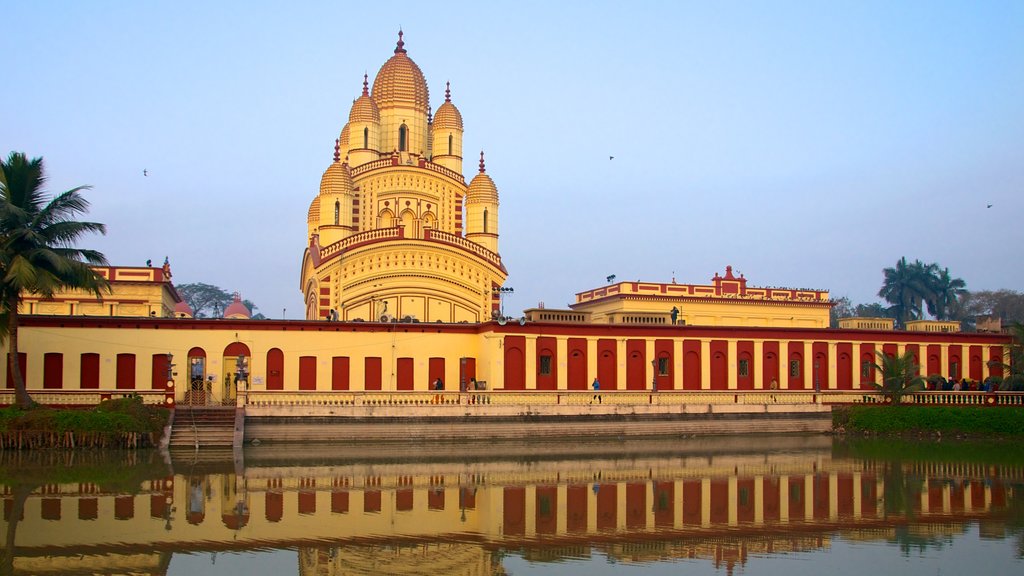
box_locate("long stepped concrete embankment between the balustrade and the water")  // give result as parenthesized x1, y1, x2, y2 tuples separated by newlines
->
(245, 404, 831, 444)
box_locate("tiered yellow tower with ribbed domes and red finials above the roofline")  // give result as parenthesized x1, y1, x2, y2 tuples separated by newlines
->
(299, 32, 507, 323)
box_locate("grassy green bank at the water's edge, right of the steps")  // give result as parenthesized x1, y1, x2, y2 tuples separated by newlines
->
(833, 406, 1024, 439)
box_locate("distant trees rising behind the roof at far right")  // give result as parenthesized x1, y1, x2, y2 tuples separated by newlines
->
(831, 256, 1024, 330)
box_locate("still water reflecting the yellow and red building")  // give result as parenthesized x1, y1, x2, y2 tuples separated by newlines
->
(0, 437, 1024, 576)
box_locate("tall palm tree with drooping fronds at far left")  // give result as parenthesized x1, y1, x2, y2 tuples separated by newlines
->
(0, 152, 110, 408)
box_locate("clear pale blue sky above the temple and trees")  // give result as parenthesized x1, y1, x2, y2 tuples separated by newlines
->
(0, 0, 1024, 319)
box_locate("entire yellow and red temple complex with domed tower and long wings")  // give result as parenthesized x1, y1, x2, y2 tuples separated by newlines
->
(0, 33, 1012, 407)
